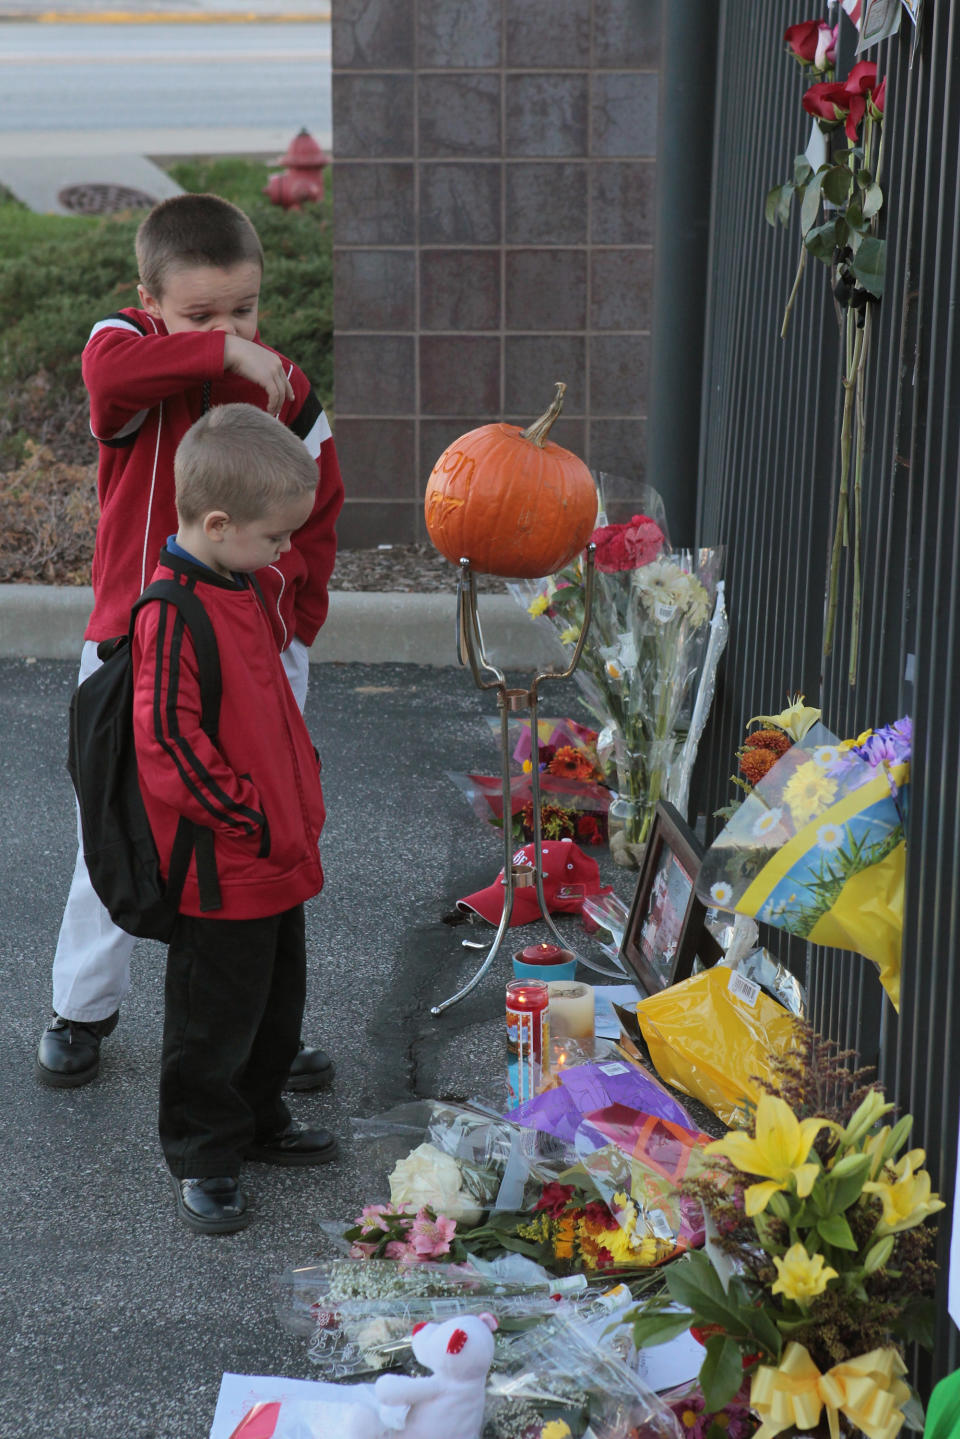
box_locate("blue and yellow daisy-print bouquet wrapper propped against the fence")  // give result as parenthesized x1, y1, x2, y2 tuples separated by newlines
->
(697, 720, 911, 1009)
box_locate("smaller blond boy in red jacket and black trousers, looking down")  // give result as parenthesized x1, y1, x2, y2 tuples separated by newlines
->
(132, 404, 337, 1233)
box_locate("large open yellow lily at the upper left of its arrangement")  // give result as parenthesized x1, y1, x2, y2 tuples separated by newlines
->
(705, 1094, 829, 1217)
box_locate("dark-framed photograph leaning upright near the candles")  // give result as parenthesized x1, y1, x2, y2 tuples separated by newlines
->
(620, 800, 721, 994)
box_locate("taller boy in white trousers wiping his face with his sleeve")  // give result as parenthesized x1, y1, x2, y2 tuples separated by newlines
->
(36, 194, 343, 1088)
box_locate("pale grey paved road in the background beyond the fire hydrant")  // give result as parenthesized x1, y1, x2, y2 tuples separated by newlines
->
(0, 23, 331, 135)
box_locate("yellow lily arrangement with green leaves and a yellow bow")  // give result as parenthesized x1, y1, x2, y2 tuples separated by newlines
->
(633, 1027, 943, 1439)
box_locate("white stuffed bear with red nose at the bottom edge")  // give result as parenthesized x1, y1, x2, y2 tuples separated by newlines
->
(272, 1314, 497, 1439)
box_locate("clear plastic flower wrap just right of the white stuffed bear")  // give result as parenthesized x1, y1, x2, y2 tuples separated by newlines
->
(484, 1307, 682, 1439)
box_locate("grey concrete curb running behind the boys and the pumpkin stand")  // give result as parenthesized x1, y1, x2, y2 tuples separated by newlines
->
(0, 584, 561, 671)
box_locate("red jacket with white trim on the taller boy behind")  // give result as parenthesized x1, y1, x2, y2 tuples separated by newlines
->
(82, 309, 344, 649)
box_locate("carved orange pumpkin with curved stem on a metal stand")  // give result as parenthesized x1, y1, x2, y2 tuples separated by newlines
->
(423, 381, 597, 580)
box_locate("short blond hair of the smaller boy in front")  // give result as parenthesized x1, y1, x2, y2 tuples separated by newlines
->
(173, 404, 318, 525)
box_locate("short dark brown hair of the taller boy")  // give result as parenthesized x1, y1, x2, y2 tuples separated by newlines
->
(135, 194, 263, 299)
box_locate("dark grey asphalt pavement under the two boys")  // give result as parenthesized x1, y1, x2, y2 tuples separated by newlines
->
(0, 658, 635, 1439)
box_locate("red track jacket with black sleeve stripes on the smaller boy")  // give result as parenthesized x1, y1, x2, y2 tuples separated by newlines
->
(132, 550, 325, 920)
